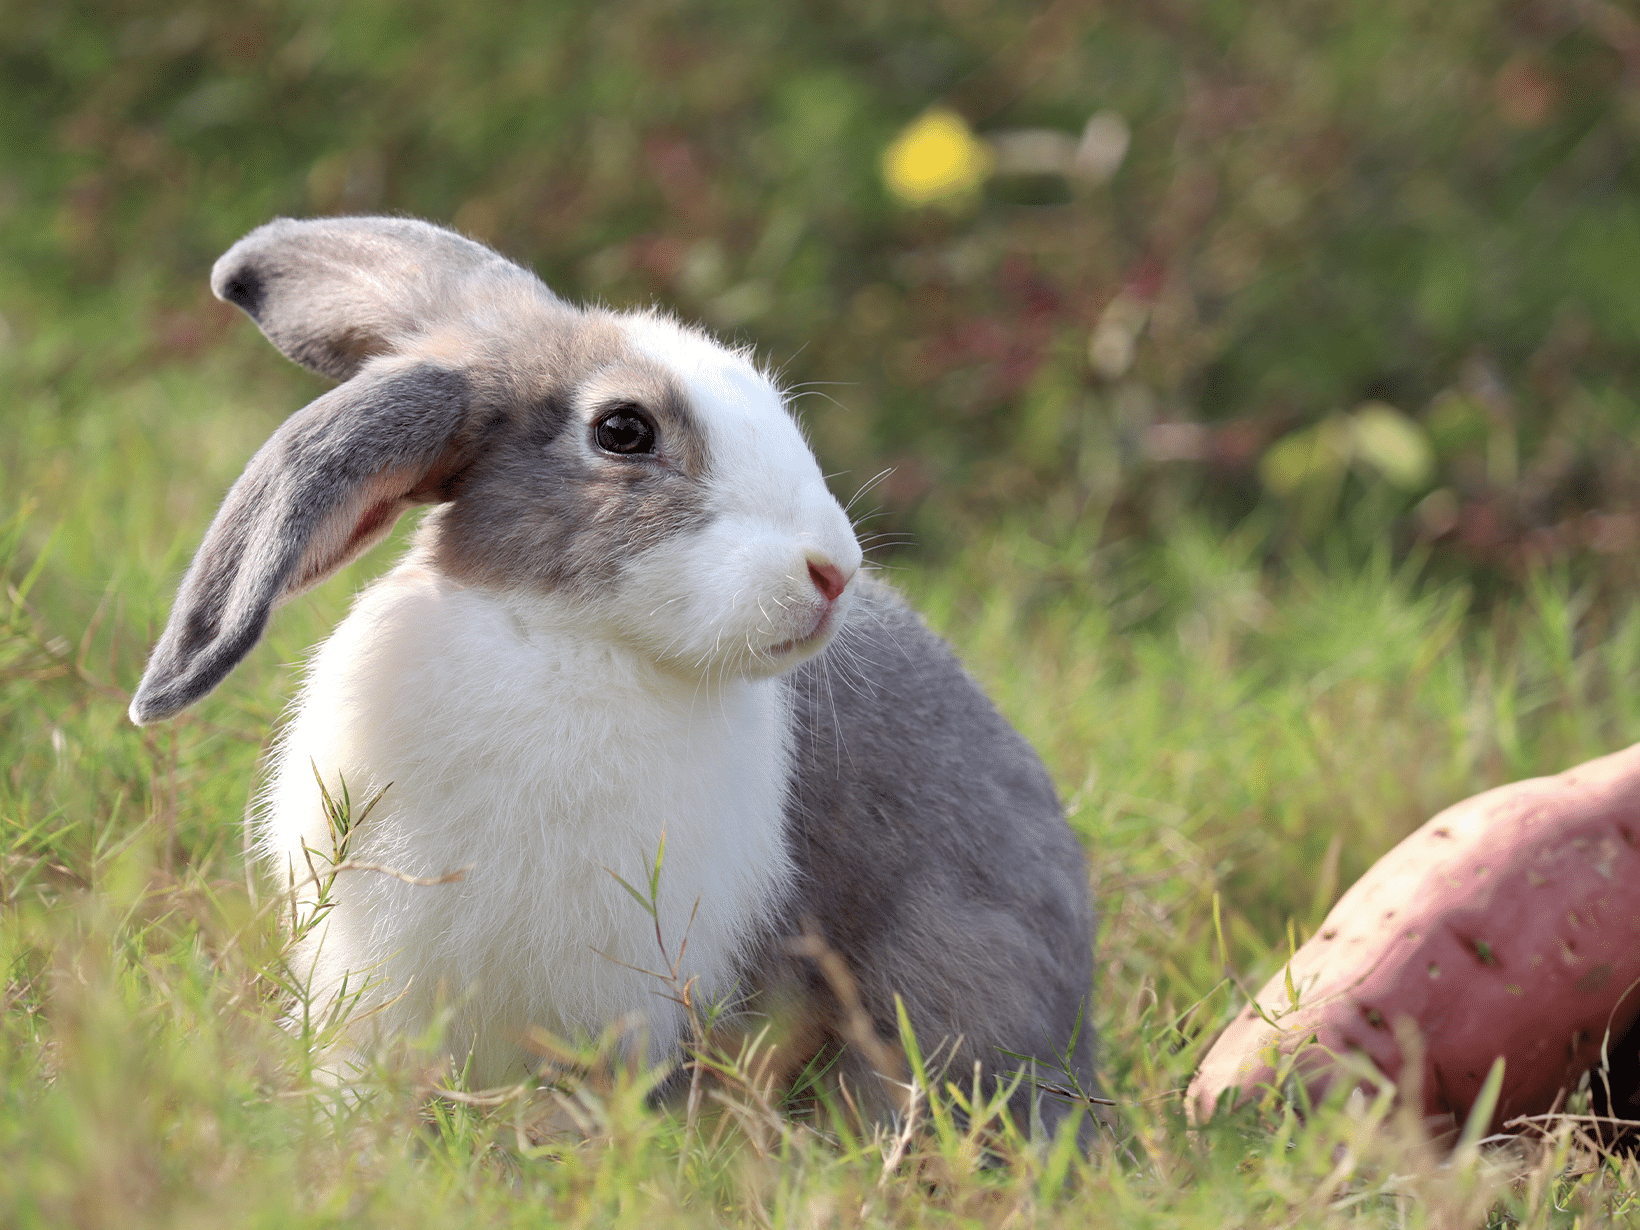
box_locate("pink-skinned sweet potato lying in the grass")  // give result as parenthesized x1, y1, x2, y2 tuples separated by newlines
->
(1187, 745, 1640, 1130)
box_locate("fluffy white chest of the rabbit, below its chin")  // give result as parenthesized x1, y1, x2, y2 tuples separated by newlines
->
(259, 563, 790, 1082)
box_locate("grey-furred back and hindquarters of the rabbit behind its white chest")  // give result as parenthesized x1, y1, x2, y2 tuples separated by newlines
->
(748, 579, 1096, 1130)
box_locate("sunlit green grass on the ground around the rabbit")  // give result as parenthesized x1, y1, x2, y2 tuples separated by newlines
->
(9, 328, 1640, 1228)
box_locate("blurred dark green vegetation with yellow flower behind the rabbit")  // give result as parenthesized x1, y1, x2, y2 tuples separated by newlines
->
(9, 0, 1640, 582)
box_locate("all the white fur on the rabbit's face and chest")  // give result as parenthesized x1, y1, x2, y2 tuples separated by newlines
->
(257, 317, 859, 1084)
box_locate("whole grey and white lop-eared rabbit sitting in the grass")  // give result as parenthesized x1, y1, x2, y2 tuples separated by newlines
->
(130, 216, 1096, 1130)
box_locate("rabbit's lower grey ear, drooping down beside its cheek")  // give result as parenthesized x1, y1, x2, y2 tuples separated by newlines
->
(131, 359, 477, 727)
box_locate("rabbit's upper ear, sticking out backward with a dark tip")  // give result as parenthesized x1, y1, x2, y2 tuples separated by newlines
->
(210, 218, 558, 380)
